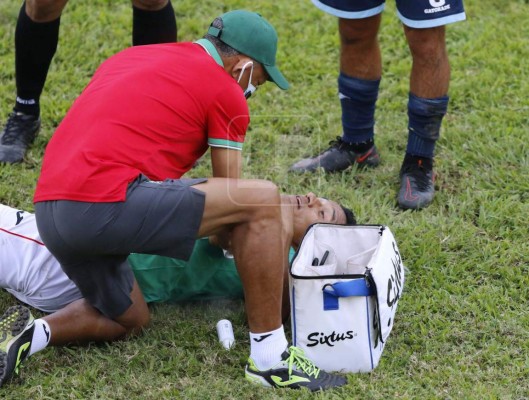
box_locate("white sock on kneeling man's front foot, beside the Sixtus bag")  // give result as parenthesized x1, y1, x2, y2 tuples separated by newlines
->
(250, 325, 288, 371)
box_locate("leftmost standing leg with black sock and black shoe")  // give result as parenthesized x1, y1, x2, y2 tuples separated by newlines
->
(0, 0, 68, 163)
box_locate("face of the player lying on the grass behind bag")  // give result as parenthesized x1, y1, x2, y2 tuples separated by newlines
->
(289, 193, 347, 233)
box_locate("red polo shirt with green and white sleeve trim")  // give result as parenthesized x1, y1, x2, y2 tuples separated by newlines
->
(34, 43, 249, 202)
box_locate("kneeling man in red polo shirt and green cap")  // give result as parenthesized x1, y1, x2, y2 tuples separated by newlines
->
(13, 10, 346, 390)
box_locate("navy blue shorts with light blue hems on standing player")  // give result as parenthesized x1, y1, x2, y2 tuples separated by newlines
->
(312, 0, 466, 28)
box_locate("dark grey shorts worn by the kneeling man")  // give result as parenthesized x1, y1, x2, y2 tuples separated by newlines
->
(35, 175, 206, 318)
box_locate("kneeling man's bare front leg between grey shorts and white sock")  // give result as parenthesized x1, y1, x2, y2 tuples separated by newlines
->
(195, 179, 288, 332)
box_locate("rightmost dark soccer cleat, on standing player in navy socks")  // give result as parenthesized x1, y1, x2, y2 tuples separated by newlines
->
(398, 155, 435, 210)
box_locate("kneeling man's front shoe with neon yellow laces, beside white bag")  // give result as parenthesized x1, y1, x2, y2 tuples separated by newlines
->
(245, 346, 347, 392)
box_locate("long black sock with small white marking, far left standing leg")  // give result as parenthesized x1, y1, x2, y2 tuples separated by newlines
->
(15, 3, 61, 115)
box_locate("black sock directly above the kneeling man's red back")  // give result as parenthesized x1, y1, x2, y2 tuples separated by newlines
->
(132, 0, 177, 46)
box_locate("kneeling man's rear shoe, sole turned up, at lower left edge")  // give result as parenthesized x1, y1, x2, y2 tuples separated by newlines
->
(0, 305, 35, 386)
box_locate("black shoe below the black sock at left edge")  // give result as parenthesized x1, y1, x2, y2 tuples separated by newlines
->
(0, 111, 40, 163)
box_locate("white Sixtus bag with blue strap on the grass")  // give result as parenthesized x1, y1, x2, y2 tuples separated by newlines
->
(290, 224, 404, 372)
